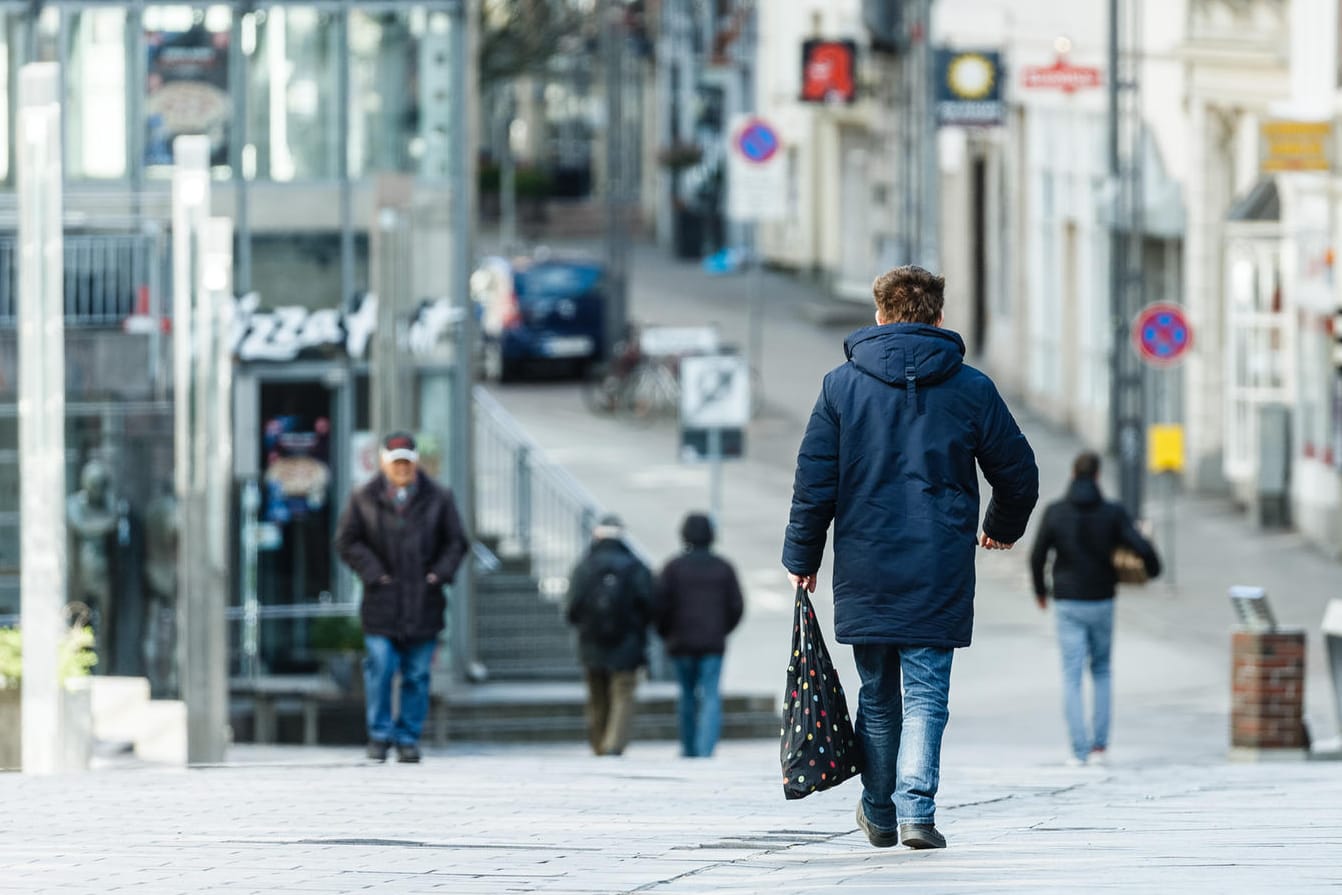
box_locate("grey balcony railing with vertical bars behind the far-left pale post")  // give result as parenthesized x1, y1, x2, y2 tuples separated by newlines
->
(0, 233, 169, 327)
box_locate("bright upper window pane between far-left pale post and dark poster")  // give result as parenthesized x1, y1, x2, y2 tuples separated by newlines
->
(66, 9, 126, 180)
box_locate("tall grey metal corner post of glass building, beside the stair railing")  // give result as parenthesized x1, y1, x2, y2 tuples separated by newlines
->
(448, 0, 475, 675)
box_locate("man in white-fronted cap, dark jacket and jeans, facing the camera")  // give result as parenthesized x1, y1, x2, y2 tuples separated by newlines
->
(336, 432, 468, 762)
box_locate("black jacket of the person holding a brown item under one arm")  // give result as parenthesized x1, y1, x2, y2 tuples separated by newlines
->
(1029, 479, 1161, 600)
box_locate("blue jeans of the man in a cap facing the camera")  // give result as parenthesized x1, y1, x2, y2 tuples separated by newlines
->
(364, 633, 437, 746)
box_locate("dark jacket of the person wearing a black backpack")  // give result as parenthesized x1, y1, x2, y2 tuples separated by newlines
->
(566, 538, 652, 671)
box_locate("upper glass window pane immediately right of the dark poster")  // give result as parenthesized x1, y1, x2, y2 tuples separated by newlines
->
(242, 5, 340, 181)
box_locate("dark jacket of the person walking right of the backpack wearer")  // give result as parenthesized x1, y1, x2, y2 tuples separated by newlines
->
(652, 547, 745, 656)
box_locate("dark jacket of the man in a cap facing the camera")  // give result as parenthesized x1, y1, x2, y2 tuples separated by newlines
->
(336, 472, 468, 640)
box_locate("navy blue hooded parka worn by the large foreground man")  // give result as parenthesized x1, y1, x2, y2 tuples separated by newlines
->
(782, 323, 1039, 647)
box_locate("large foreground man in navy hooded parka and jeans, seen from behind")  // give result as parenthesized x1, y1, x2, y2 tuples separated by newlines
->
(782, 266, 1039, 848)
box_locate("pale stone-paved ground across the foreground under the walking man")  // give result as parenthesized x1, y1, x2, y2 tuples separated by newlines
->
(0, 741, 1342, 895)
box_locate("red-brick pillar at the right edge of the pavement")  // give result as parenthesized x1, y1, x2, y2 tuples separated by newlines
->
(1231, 631, 1310, 758)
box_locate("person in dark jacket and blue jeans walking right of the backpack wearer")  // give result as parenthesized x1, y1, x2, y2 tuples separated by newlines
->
(652, 513, 745, 758)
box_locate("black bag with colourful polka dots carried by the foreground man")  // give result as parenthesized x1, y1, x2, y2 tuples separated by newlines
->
(780, 588, 862, 798)
